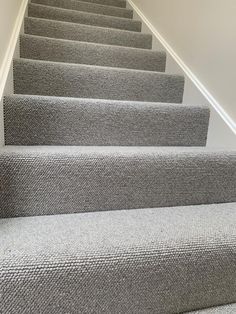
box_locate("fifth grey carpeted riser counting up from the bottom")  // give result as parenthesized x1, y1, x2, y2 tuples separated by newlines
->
(20, 35, 166, 72)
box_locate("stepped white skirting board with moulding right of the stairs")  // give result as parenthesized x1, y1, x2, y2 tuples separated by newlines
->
(127, 0, 236, 148)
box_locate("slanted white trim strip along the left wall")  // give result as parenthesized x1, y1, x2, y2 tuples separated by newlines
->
(0, 0, 28, 99)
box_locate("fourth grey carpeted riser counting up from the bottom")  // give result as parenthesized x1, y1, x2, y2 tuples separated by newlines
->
(14, 59, 184, 103)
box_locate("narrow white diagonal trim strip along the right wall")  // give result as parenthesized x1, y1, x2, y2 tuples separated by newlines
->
(127, 0, 236, 135)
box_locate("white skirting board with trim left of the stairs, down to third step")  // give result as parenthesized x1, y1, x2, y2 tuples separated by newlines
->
(0, 0, 29, 146)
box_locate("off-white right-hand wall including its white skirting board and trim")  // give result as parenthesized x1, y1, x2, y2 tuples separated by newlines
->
(128, 0, 236, 148)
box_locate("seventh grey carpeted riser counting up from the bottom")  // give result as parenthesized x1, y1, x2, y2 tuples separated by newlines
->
(28, 3, 142, 32)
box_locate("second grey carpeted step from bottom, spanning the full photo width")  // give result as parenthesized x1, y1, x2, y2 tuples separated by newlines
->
(0, 146, 236, 217)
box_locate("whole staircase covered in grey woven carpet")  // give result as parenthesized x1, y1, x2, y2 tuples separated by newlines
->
(0, 0, 236, 314)
